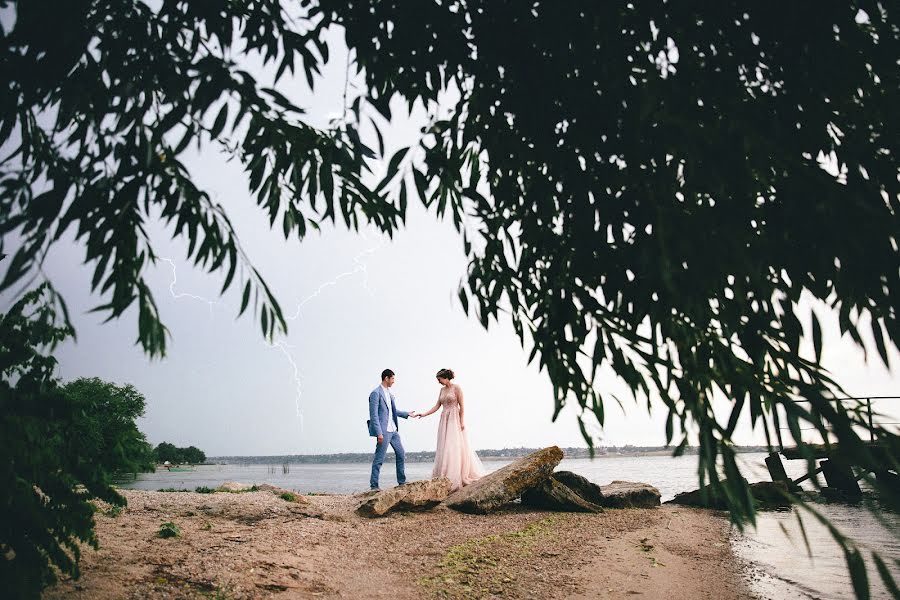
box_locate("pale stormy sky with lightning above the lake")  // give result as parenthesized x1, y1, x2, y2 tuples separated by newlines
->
(8, 24, 900, 456)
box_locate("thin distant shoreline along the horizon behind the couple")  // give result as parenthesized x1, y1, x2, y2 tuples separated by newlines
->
(205, 446, 768, 465)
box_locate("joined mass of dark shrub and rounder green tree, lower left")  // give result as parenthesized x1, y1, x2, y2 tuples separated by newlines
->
(0, 285, 152, 598)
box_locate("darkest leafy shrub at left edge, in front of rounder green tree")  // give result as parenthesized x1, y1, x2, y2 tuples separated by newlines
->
(0, 288, 81, 597)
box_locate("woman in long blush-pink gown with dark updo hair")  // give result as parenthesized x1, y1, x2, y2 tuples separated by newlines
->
(410, 369, 484, 490)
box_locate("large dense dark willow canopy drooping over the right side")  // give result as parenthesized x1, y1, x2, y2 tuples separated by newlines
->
(323, 0, 900, 596)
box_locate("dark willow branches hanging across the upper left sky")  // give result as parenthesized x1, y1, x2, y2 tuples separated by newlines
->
(0, 0, 399, 354)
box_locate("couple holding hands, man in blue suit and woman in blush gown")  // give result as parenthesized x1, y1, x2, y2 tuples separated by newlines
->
(368, 369, 484, 490)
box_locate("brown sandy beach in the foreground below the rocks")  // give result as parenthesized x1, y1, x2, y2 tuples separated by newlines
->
(45, 490, 749, 600)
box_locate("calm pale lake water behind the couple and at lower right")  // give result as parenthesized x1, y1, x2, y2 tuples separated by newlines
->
(121, 454, 900, 600)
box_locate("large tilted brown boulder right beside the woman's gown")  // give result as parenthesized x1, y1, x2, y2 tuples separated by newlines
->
(446, 446, 563, 514)
